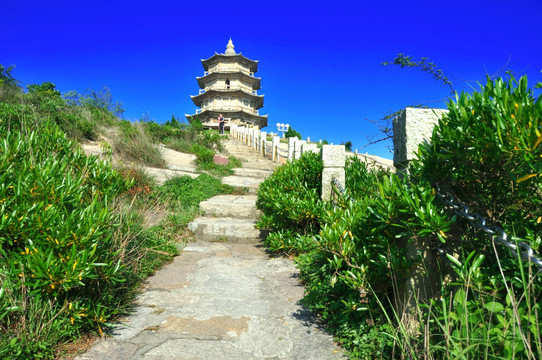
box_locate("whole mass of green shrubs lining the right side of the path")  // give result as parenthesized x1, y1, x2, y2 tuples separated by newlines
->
(258, 74, 542, 359)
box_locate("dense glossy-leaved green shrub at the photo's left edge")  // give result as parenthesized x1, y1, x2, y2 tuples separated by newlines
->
(0, 119, 133, 358)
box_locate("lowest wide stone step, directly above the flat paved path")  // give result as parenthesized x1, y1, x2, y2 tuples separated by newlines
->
(188, 216, 265, 244)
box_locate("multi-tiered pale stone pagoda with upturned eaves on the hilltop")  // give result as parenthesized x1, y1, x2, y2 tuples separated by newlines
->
(185, 39, 267, 129)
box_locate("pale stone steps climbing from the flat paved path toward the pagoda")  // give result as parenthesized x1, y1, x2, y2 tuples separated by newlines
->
(188, 141, 280, 244)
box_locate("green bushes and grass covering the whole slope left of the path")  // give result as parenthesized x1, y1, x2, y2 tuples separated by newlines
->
(0, 66, 238, 359)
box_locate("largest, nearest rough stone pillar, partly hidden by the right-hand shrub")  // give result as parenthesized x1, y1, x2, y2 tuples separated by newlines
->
(393, 107, 448, 171)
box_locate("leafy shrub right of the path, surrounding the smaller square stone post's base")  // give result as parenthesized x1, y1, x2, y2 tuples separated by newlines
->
(257, 154, 450, 358)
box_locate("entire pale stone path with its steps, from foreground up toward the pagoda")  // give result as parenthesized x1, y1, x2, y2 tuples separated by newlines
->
(77, 138, 345, 360)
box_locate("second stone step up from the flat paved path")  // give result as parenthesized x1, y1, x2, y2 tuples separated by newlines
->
(199, 195, 261, 219)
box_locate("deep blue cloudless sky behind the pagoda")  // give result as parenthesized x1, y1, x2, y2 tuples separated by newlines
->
(0, 0, 542, 158)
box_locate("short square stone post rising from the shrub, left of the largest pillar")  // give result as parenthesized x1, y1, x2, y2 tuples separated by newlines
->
(321, 145, 346, 201)
